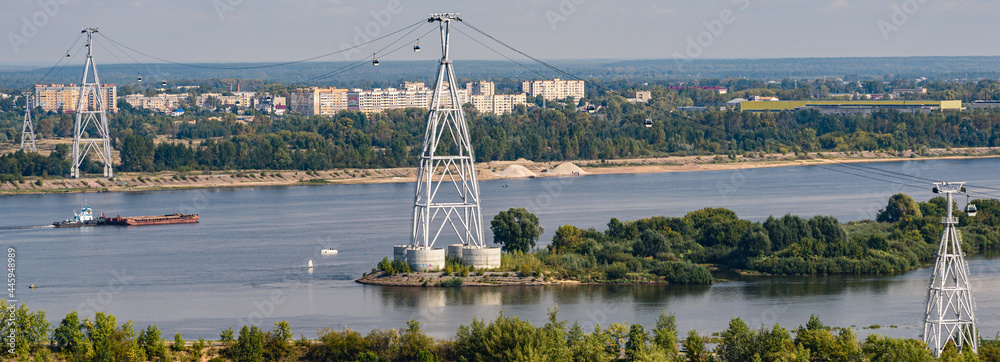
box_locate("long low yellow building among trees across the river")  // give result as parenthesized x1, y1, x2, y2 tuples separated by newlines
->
(737, 100, 962, 114)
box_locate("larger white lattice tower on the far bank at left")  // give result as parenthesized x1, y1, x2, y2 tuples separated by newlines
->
(70, 28, 114, 178)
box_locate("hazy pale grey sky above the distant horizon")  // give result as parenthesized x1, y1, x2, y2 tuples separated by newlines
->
(0, 0, 1000, 65)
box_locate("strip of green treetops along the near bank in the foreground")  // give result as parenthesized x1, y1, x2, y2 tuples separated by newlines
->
(0, 301, 1000, 362)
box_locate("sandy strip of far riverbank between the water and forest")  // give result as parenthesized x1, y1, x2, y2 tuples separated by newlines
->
(0, 148, 1000, 195)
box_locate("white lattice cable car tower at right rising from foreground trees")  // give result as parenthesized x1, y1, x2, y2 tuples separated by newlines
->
(924, 182, 979, 357)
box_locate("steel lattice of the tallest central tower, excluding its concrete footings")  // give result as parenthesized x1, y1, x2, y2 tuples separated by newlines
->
(410, 13, 483, 249)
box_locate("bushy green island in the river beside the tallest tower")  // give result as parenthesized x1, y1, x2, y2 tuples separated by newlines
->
(358, 194, 1000, 287)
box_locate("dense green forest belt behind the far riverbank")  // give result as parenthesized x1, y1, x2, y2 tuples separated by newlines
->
(0, 80, 1000, 177)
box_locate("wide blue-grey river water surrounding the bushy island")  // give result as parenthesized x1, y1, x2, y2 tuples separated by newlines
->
(0, 159, 1000, 339)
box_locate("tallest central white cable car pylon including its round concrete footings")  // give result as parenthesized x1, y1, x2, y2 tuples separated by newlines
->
(393, 13, 500, 271)
